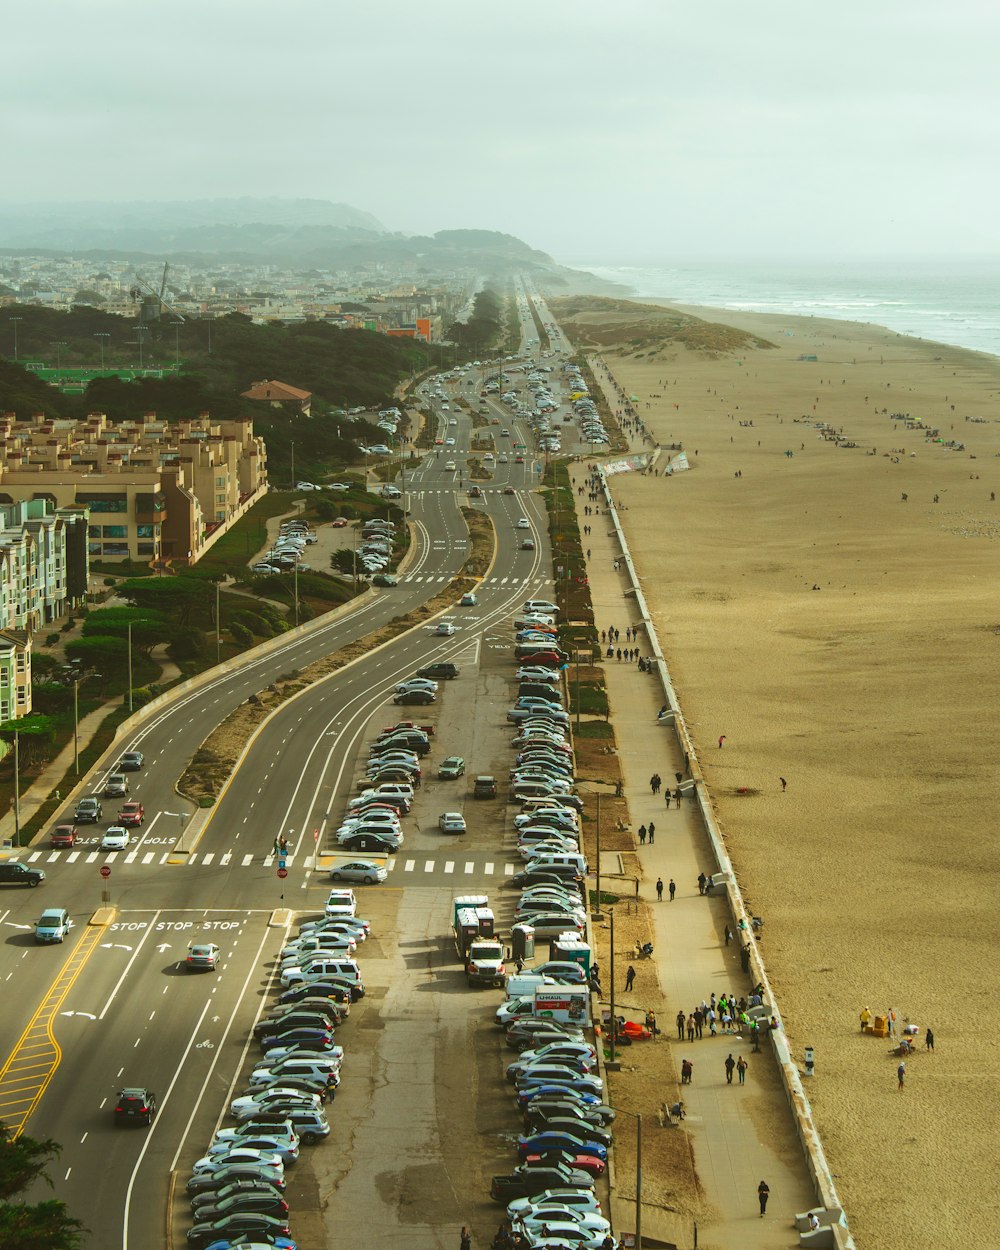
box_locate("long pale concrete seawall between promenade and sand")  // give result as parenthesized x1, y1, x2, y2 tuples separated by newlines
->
(601, 473, 855, 1250)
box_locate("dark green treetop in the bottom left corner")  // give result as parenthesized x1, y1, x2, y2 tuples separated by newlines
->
(0, 1124, 84, 1250)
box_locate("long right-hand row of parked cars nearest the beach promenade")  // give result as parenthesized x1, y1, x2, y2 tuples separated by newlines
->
(490, 601, 615, 1250)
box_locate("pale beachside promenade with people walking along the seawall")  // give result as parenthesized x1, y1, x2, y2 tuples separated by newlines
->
(573, 477, 816, 1250)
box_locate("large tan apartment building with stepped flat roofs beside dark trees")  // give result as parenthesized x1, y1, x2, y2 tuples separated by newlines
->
(0, 413, 268, 564)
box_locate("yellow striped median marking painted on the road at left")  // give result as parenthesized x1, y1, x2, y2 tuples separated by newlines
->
(0, 928, 105, 1138)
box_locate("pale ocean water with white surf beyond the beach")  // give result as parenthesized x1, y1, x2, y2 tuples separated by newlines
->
(566, 258, 1000, 356)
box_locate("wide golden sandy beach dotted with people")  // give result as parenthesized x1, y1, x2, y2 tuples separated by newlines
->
(555, 297, 1000, 1250)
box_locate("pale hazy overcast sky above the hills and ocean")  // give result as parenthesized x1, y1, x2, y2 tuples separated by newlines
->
(0, 0, 1000, 264)
